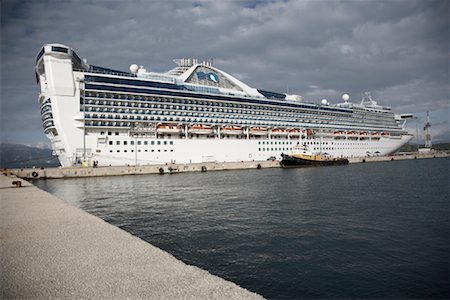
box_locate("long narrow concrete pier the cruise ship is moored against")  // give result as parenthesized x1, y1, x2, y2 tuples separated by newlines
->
(8, 151, 450, 179)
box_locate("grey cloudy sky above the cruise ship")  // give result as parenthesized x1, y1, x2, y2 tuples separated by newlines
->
(1, 0, 450, 146)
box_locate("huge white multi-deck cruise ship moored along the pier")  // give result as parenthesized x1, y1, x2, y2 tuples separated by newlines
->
(35, 44, 412, 167)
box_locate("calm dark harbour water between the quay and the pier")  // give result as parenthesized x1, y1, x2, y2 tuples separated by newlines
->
(35, 159, 450, 299)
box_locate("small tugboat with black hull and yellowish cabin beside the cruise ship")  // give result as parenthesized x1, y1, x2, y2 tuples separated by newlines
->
(280, 144, 348, 168)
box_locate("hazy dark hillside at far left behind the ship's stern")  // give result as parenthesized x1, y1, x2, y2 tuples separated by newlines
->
(0, 143, 60, 169)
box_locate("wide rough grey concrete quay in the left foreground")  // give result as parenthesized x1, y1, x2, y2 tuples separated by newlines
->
(0, 175, 262, 299)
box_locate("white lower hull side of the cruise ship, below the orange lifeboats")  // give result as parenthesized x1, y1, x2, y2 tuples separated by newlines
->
(63, 134, 410, 166)
